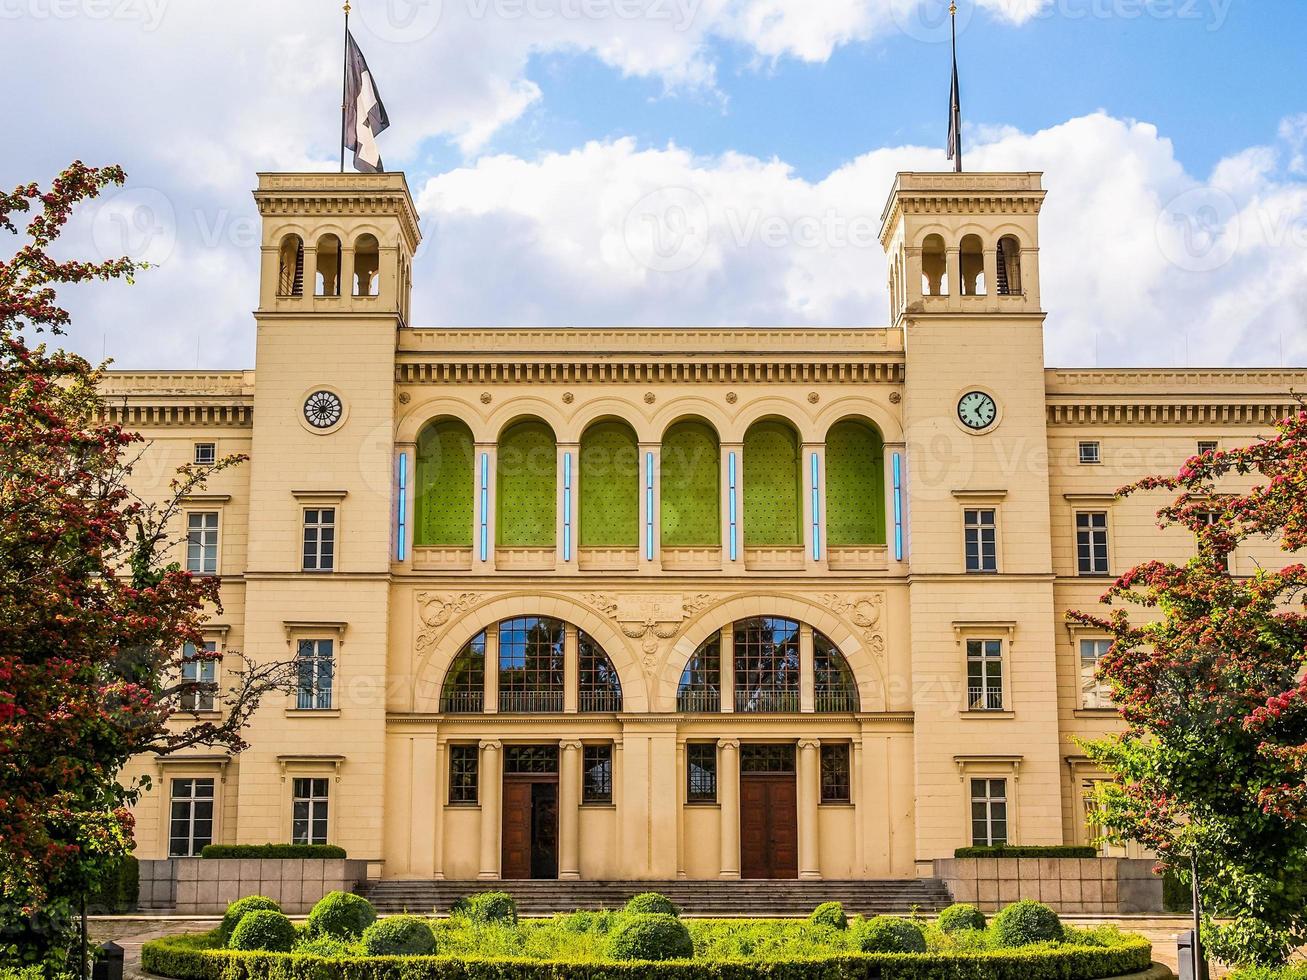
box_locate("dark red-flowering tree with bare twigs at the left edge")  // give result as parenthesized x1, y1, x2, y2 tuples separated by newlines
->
(0, 162, 290, 966)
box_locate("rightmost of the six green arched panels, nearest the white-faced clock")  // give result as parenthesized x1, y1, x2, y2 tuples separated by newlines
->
(826, 419, 885, 547)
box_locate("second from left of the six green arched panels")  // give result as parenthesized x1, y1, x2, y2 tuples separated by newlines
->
(497, 419, 558, 547)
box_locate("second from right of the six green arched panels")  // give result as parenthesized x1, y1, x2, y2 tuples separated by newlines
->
(744, 419, 804, 547)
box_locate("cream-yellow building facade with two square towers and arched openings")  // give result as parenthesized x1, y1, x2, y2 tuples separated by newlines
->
(105, 174, 1307, 881)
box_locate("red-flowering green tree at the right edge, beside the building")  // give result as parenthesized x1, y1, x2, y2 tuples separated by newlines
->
(1070, 413, 1307, 964)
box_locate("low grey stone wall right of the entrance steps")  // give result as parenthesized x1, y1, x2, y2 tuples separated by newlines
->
(935, 857, 1162, 915)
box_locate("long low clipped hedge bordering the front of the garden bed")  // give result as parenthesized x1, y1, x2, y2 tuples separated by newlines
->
(141, 936, 1153, 980)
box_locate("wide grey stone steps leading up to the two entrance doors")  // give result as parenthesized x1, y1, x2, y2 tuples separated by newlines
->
(359, 878, 953, 919)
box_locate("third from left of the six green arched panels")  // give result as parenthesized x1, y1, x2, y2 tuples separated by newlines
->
(580, 419, 640, 547)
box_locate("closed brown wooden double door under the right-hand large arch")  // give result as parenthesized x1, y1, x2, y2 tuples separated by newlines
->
(740, 745, 799, 878)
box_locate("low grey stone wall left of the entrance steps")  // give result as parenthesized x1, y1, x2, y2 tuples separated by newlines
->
(140, 857, 367, 915)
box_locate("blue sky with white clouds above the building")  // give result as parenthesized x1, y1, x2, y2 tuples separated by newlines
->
(0, 0, 1307, 367)
